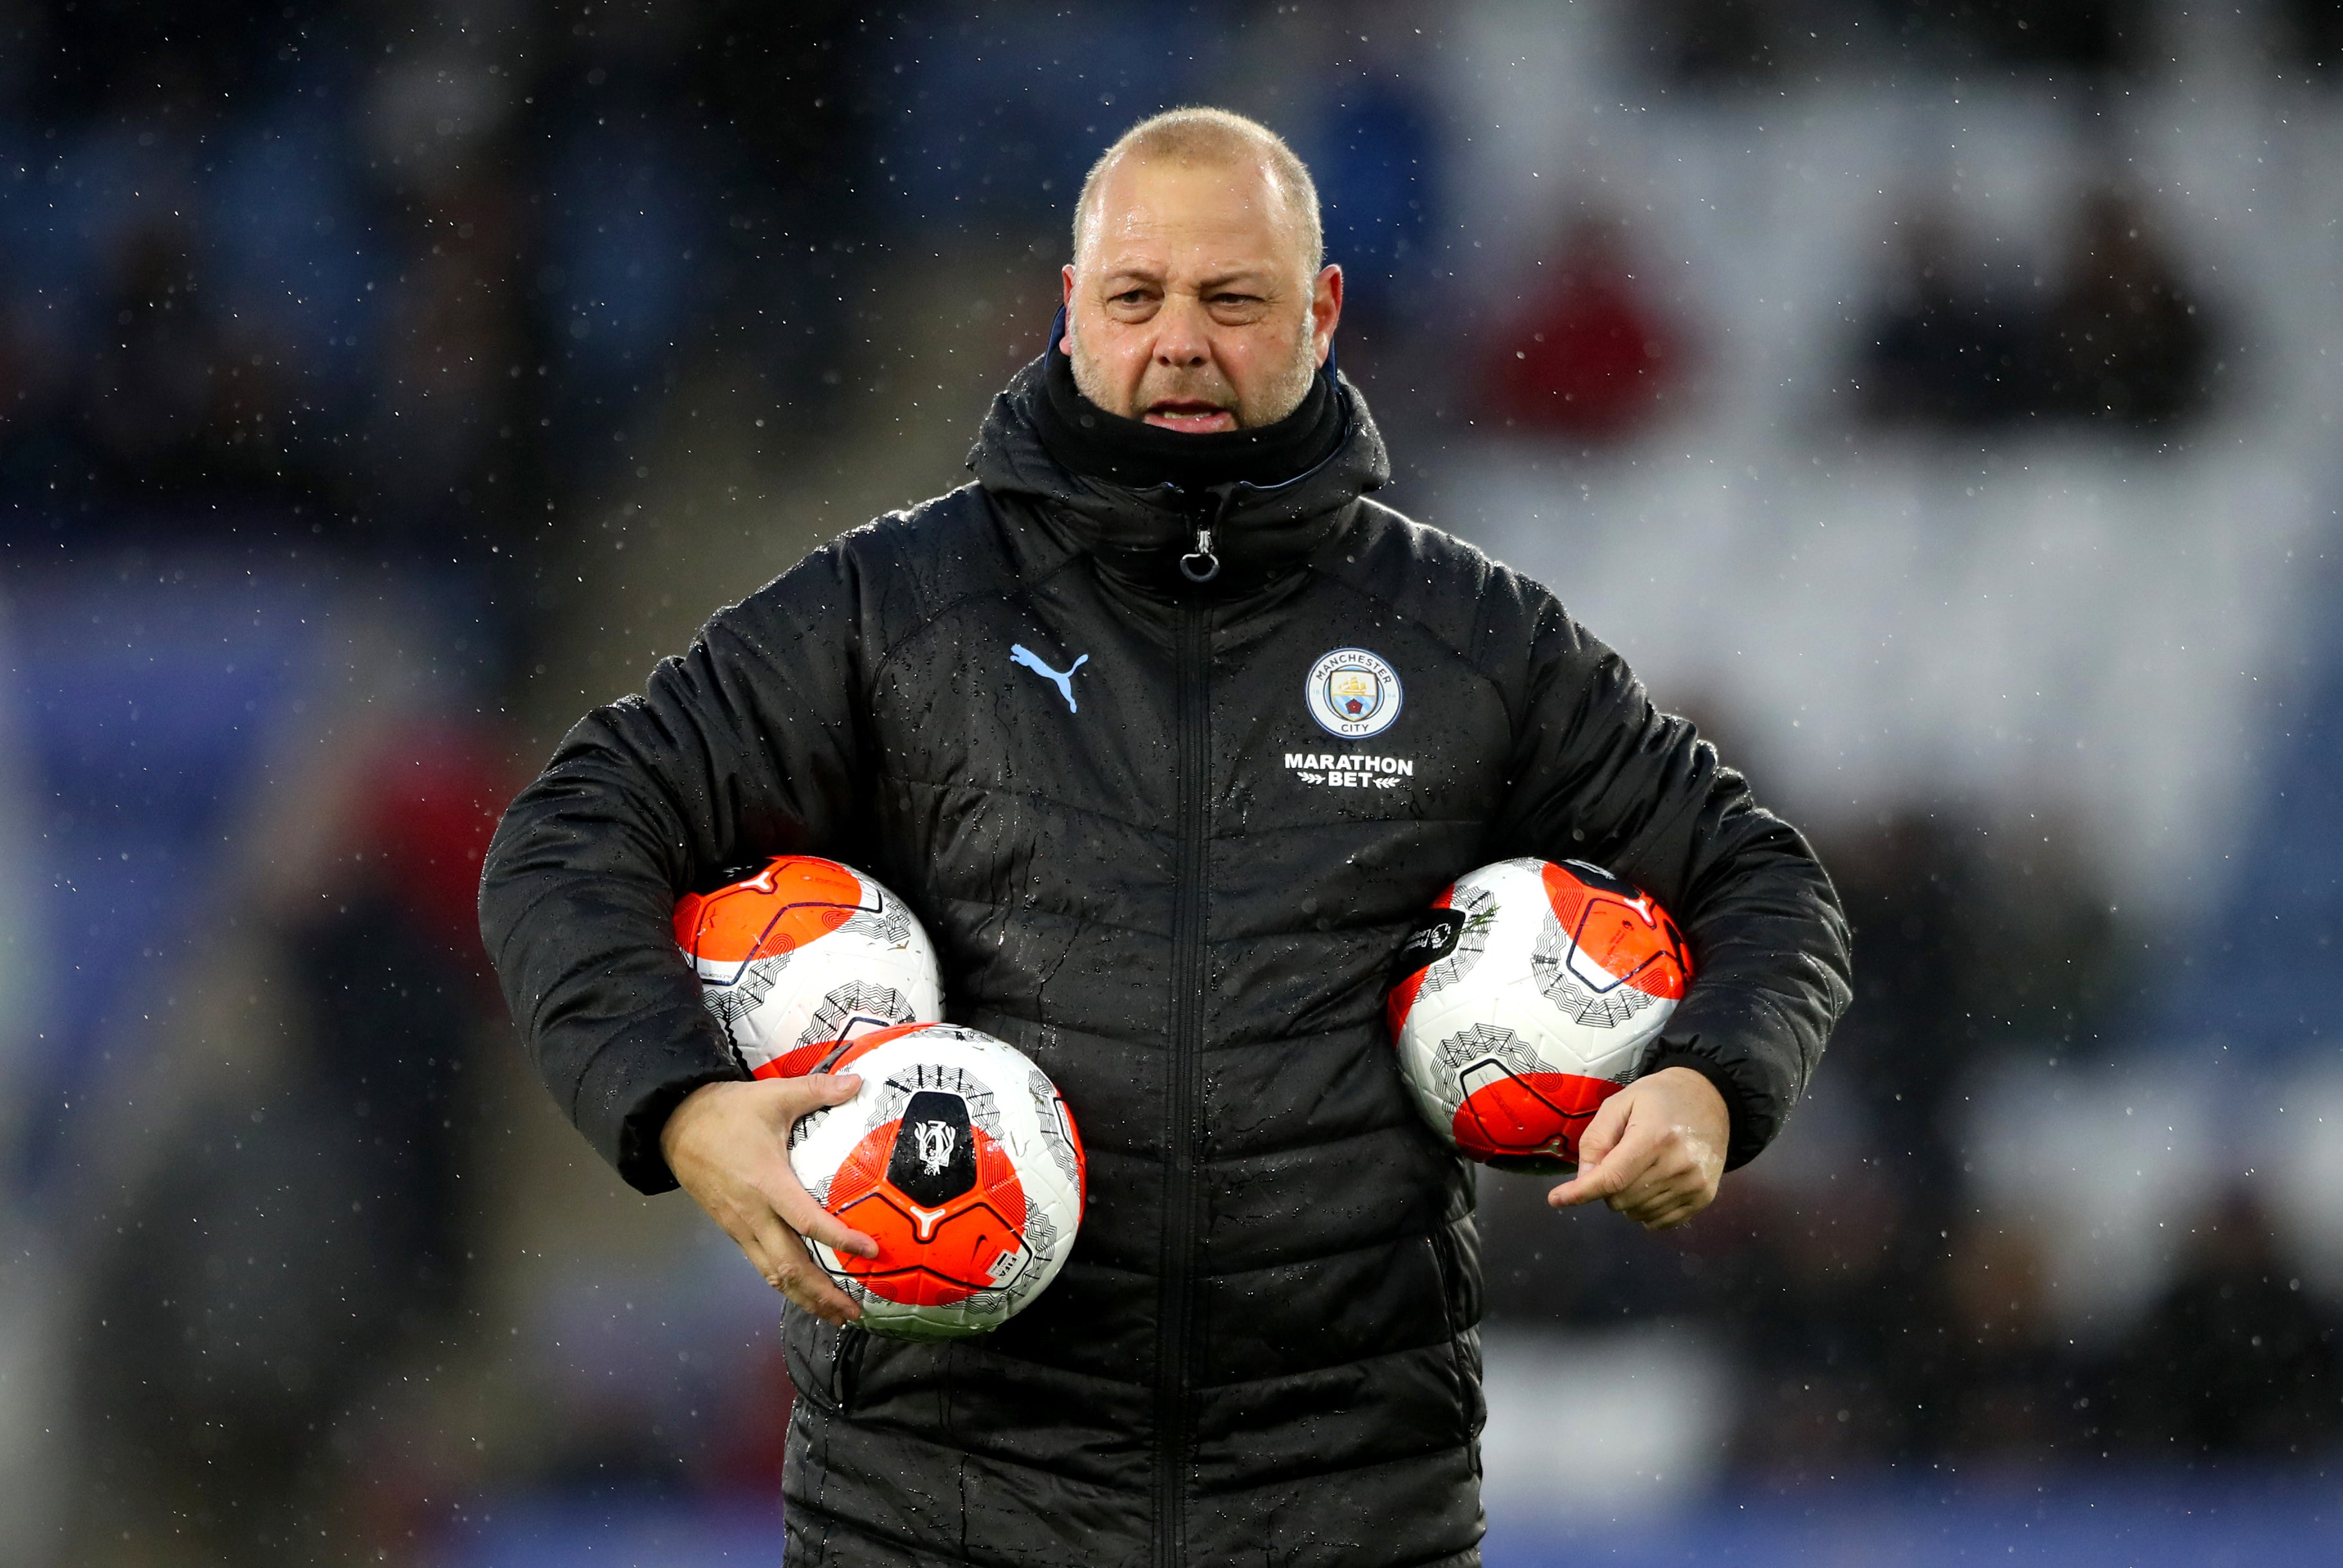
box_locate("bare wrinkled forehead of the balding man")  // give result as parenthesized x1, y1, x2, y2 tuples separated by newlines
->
(1083, 157, 1303, 267)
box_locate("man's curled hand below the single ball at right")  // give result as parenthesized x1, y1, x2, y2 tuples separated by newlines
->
(1547, 1066, 1734, 1230)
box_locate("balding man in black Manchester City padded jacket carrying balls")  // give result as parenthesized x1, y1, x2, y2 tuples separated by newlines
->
(482, 110, 1846, 1565)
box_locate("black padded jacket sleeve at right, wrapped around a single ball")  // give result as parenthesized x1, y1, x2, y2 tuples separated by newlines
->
(1497, 600, 1849, 1167)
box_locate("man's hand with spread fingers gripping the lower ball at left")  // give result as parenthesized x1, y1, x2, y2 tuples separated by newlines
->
(658, 1073, 879, 1324)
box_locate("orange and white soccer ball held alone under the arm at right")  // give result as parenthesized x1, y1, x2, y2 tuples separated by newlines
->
(1390, 860, 1692, 1172)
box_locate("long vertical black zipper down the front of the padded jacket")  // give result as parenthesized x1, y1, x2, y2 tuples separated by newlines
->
(1155, 605, 1211, 1568)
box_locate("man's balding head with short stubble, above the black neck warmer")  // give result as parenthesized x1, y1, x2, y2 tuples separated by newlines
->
(1063, 108, 1343, 432)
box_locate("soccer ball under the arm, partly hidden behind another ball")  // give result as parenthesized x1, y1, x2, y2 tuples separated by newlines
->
(675, 855, 944, 1078)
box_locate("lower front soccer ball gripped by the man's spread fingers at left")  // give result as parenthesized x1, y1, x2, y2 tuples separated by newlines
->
(789, 1025, 1085, 1338)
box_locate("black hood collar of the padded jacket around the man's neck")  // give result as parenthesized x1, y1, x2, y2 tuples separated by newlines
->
(968, 347, 1392, 596)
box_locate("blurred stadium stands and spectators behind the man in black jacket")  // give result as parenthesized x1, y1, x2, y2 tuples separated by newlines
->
(0, 0, 2343, 1568)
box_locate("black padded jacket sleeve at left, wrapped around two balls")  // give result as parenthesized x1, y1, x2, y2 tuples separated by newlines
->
(481, 543, 862, 1193)
